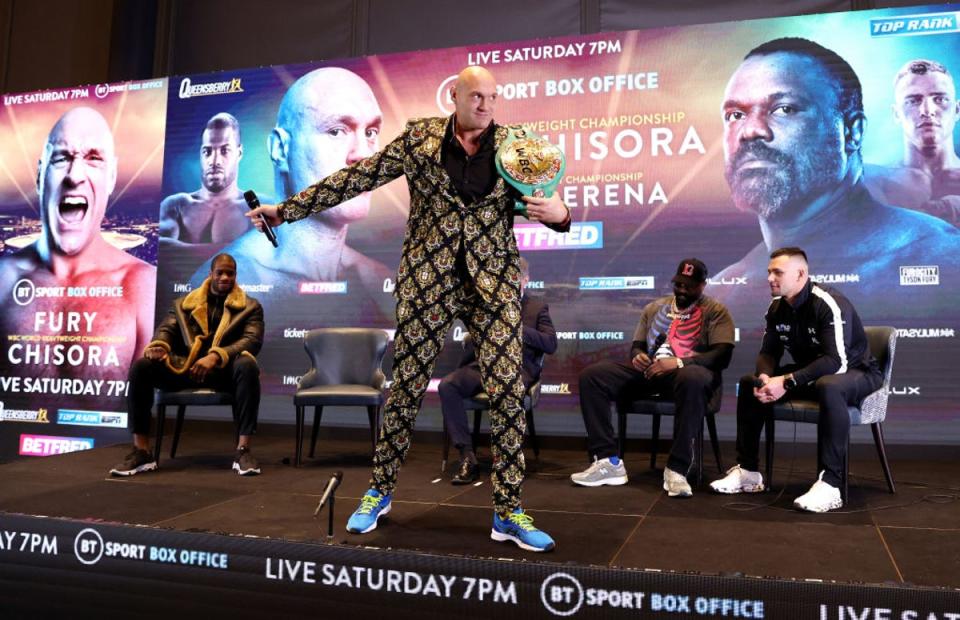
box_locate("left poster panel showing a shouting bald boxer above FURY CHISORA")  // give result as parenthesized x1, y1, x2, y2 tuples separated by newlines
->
(0, 79, 167, 456)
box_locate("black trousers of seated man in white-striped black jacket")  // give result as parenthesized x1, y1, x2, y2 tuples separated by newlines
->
(737, 369, 883, 488)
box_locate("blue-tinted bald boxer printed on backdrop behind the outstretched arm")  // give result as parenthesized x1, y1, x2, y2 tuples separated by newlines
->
(191, 67, 392, 292)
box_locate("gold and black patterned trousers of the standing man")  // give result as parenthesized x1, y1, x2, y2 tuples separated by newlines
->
(370, 272, 526, 513)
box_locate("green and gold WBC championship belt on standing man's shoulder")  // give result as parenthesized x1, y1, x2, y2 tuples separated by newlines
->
(495, 127, 567, 217)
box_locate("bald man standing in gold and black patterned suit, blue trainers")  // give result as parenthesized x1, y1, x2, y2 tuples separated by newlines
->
(249, 67, 571, 551)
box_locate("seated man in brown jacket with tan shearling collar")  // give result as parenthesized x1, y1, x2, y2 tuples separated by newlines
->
(110, 254, 263, 476)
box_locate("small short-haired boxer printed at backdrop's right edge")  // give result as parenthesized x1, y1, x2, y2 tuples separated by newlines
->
(864, 58, 960, 226)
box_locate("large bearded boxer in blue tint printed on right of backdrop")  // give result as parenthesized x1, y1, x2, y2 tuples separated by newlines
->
(716, 38, 960, 319)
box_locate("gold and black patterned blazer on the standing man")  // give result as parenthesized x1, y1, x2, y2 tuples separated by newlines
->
(278, 116, 566, 305)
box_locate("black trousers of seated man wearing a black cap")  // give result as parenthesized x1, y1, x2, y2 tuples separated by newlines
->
(580, 361, 721, 474)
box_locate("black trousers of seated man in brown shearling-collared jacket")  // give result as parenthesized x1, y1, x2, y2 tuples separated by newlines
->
(127, 355, 260, 435)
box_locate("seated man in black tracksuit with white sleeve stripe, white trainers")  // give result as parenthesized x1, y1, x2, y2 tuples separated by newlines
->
(710, 247, 883, 512)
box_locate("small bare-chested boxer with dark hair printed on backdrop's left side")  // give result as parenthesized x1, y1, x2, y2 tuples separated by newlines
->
(160, 112, 251, 262)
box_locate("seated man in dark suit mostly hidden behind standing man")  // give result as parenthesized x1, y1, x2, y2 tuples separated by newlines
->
(440, 258, 557, 484)
